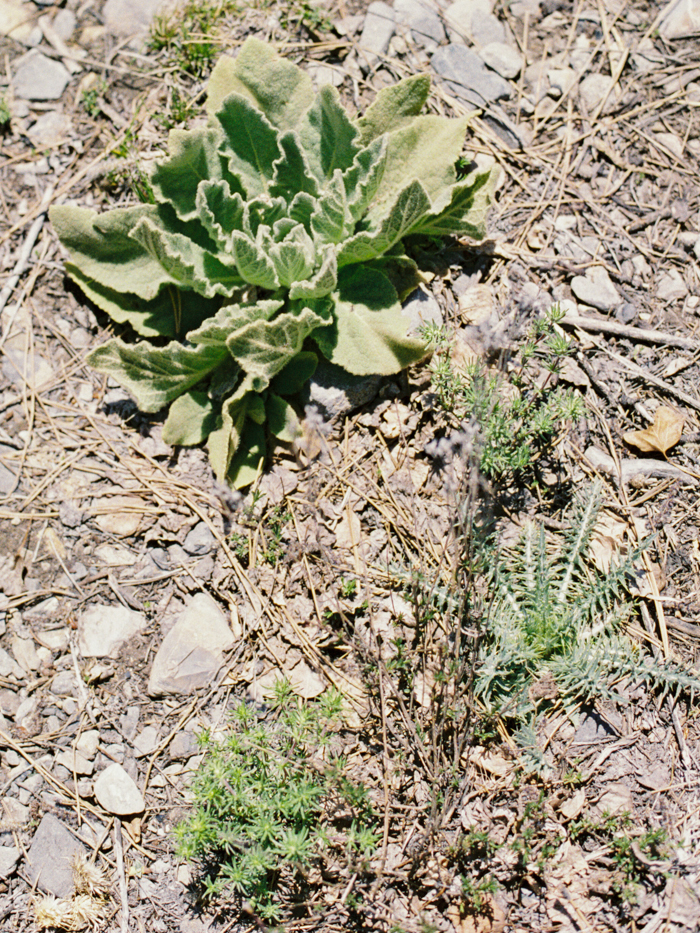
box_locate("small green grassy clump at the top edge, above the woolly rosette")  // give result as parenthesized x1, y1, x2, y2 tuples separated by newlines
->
(148, 0, 240, 77)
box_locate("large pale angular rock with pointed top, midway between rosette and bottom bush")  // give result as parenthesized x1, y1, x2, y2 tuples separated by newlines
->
(148, 593, 234, 696)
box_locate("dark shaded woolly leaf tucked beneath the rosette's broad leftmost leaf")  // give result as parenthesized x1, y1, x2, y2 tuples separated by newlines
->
(66, 262, 219, 337)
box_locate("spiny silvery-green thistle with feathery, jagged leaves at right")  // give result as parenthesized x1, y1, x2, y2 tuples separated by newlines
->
(474, 484, 700, 770)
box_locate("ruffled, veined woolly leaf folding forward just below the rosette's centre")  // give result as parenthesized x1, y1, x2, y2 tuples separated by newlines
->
(226, 308, 329, 385)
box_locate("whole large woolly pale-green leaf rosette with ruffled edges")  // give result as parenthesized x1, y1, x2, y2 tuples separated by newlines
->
(51, 39, 492, 486)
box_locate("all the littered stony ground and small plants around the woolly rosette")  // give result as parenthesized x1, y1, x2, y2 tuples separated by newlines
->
(0, 0, 700, 933)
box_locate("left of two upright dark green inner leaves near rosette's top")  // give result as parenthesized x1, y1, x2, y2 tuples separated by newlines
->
(216, 94, 282, 197)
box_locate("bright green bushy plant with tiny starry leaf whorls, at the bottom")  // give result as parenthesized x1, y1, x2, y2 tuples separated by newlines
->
(175, 681, 378, 921)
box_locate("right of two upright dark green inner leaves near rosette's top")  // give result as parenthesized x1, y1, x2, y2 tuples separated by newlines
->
(299, 84, 360, 182)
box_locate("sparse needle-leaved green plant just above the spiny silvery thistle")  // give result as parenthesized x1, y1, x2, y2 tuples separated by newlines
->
(425, 308, 583, 480)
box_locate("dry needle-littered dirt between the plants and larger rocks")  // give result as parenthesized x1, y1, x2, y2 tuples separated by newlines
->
(0, 0, 700, 933)
